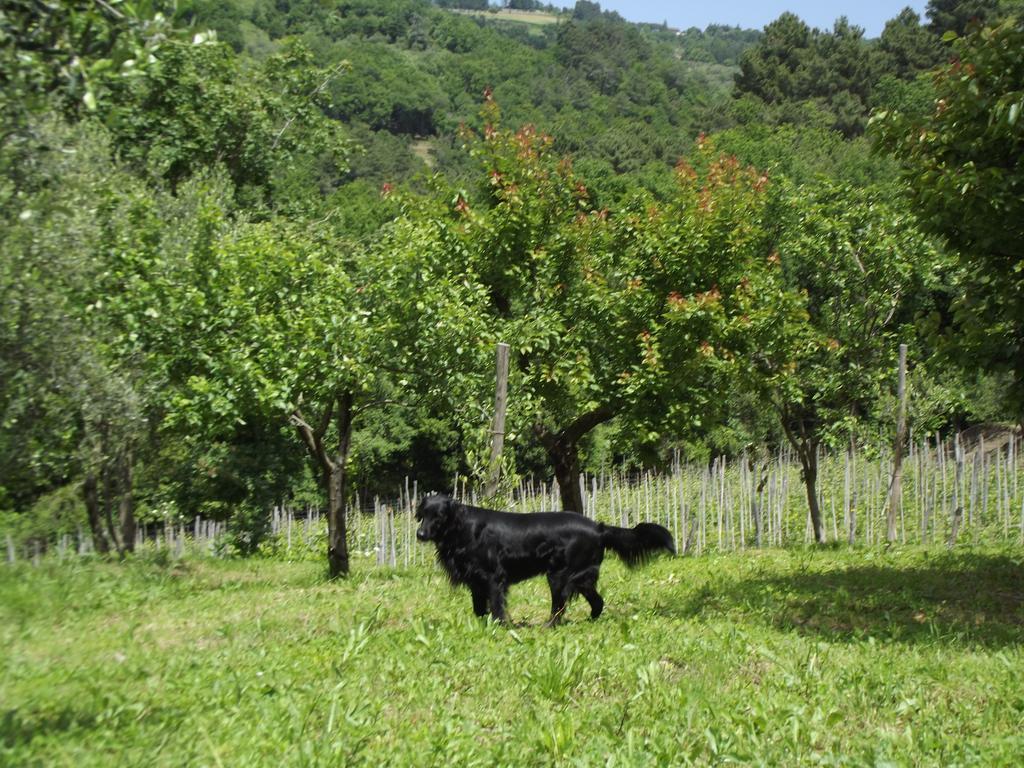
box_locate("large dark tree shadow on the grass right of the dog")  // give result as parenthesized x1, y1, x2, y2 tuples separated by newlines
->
(663, 553, 1024, 647)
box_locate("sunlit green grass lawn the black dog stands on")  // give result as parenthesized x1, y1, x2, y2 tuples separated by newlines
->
(0, 549, 1024, 766)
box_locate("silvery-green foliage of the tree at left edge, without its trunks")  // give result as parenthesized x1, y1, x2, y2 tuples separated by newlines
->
(0, 121, 159, 506)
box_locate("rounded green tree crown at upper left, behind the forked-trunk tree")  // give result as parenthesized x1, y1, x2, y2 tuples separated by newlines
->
(106, 39, 347, 210)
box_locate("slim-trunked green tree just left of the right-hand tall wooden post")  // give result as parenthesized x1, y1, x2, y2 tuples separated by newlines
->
(750, 185, 940, 542)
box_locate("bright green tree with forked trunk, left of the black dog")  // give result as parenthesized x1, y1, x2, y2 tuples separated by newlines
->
(135, 193, 487, 578)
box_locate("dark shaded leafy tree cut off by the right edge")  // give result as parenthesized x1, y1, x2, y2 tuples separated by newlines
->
(872, 18, 1024, 419)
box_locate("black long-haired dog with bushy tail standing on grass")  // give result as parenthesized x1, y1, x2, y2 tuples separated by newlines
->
(416, 495, 676, 626)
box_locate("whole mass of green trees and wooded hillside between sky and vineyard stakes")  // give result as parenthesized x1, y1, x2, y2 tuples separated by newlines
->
(0, 0, 1024, 573)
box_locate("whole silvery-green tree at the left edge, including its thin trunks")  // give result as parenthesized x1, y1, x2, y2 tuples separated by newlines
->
(0, 120, 195, 553)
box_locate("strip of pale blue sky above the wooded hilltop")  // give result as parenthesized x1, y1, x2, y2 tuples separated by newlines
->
(593, 0, 928, 37)
